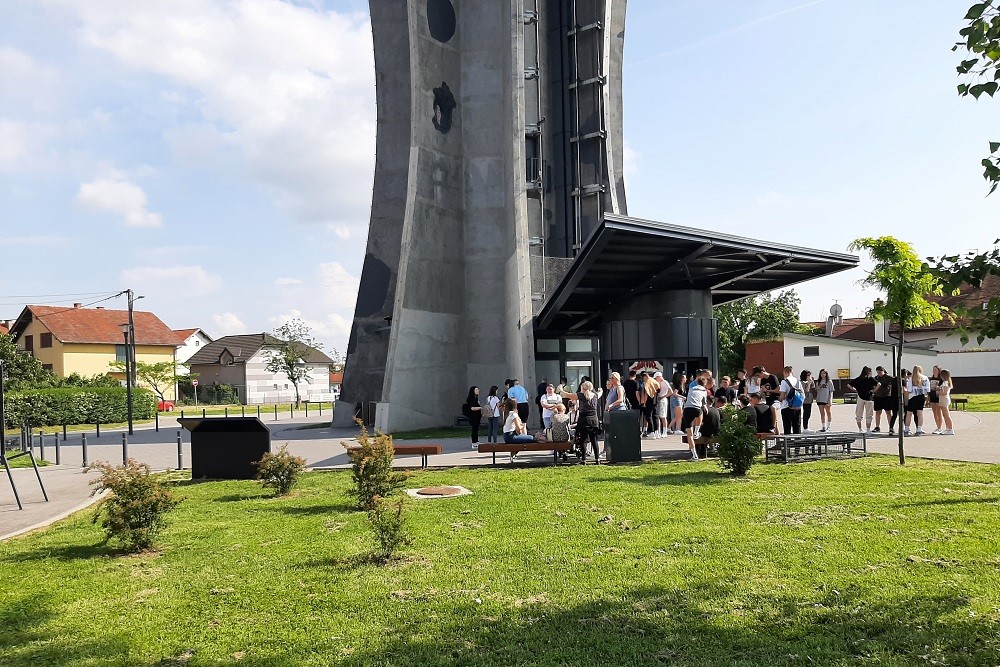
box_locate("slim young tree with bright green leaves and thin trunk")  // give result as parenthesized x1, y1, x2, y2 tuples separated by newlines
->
(849, 236, 947, 465)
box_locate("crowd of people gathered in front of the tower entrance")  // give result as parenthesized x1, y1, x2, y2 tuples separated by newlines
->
(462, 366, 955, 461)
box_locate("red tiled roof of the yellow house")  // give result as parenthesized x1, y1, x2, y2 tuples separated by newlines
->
(18, 306, 177, 347)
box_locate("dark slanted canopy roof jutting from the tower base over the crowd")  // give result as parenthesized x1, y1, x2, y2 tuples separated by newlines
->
(536, 214, 858, 335)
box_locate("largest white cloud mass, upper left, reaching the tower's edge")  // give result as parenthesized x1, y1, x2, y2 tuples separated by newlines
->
(52, 0, 375, 223)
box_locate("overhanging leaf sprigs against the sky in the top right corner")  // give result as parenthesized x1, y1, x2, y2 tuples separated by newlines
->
(951, 0, 1000, 194)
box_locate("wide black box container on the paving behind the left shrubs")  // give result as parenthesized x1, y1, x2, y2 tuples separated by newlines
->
(177, 417, 271, 479)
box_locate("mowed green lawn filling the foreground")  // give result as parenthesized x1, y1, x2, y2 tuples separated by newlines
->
(0, 457, 1000, 667)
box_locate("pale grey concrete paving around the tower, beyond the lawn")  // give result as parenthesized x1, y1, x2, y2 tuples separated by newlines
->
(0, 405, 1000, 540)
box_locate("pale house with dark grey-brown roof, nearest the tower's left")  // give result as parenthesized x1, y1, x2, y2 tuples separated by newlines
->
(187, 333, 333, 405)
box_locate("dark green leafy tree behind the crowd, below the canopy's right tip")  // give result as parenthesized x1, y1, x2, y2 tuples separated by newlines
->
(715, 290, 801, 375)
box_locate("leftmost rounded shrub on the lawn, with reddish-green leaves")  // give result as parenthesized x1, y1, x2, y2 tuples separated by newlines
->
(89, 459, 178, 552)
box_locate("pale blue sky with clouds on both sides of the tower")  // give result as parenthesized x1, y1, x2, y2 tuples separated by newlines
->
(0, 0, 1000, 350)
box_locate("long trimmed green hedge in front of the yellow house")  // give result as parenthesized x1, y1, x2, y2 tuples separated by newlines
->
(4, 387, 156, 427)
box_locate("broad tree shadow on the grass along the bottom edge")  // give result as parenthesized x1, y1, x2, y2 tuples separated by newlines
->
(339, 583, 1000, 667)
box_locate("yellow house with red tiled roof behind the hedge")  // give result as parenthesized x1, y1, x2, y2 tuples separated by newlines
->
(10, 304, 177, 398)
